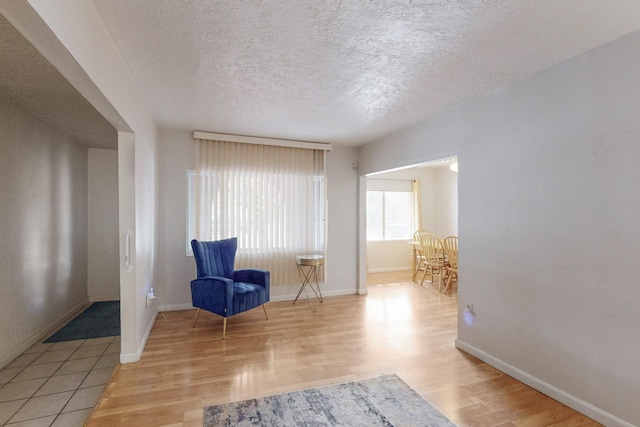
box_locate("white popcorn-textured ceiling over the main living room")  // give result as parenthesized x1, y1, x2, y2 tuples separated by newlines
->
(0, 0, 640, 146)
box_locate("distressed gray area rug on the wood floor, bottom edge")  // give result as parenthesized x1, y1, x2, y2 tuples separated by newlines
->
(204, 374, 455, 427)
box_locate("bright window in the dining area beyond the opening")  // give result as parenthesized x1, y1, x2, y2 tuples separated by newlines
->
(367, 180, 414, 240)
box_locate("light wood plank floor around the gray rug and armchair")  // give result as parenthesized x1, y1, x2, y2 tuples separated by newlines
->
(87, 272, 600, 427)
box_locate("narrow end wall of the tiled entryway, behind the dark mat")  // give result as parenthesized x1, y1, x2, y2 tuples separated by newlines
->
(87, 149, 120, 301)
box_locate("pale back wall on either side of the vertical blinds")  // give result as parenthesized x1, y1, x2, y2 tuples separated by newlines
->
(155, 130, 358, 310)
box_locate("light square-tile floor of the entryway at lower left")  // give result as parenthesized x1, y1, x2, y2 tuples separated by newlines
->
(0, 336, 120, 427)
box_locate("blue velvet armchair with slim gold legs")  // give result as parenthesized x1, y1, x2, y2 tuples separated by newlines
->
(191, 237, 270, 339)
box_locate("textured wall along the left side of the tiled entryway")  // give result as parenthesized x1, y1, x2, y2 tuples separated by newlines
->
(0, 95, 88, 367)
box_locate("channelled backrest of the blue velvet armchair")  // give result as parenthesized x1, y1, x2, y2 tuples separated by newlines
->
(191, 237, 238, 279)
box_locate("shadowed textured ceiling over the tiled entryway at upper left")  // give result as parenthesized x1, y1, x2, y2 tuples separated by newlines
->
(0, 15, 117, 148)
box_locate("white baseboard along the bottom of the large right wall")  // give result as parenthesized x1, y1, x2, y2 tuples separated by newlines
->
(456, 339, 635, 427)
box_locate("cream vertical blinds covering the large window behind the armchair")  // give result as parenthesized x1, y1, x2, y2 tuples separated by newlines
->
(195, 139, 325, 285)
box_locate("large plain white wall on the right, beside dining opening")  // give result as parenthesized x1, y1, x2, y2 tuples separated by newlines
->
(359, 32, 640, 426)
